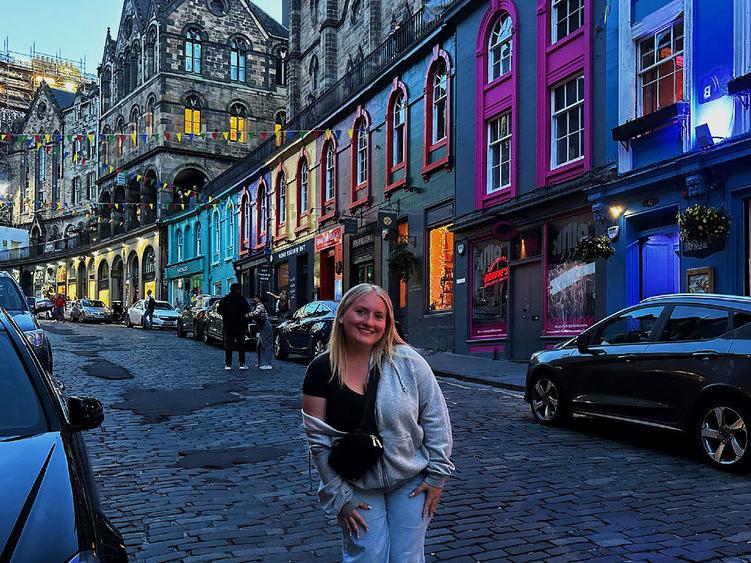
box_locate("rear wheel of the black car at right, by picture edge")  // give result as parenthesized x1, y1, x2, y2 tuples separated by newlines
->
(696, 399, 751, 471)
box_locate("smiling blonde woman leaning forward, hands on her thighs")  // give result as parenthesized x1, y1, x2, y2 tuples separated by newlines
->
(302, 284, 454, 563)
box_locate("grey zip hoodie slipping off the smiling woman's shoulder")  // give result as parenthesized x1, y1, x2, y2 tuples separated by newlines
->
(302, 345, 454, 517)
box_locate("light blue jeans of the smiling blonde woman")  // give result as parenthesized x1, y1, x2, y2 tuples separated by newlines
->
(342, 475, 430, 563)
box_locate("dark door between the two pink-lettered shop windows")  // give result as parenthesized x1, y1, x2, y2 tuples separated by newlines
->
(510, 262, 542, 360)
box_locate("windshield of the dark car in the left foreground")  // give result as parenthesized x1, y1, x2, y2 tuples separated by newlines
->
(0, 332, 47, 440)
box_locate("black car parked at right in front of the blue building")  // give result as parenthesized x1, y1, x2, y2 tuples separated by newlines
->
(525, 294, 751, 469)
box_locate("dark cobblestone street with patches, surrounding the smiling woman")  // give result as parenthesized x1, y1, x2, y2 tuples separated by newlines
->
(44, 322, 751, 562)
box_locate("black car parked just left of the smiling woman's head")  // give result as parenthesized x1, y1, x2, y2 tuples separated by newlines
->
(274, 301, 339, 360)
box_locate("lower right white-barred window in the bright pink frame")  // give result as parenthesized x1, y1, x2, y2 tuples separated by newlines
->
(552, 76, 584, 168)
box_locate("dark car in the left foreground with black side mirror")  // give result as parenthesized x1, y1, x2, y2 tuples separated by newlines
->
(0, 311, 127, 563)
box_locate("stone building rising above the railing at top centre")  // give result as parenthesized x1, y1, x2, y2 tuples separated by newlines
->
(284, 0, 425, 117)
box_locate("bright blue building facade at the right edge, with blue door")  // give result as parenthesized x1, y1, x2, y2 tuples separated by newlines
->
(588, 0, 751, 312)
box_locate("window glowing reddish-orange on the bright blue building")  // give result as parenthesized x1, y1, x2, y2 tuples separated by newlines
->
(639, 20, 683, 115)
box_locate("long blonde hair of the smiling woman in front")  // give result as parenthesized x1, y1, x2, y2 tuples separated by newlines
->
(329, 283, 405, 386)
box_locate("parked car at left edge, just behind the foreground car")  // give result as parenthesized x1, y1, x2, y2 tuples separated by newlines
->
(0, 272, 52, 373)
